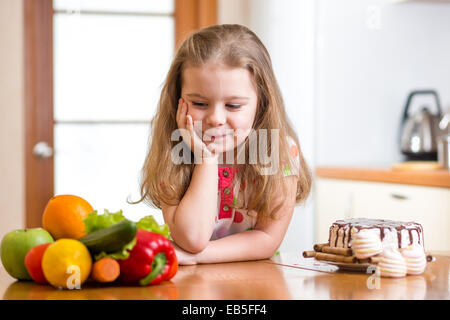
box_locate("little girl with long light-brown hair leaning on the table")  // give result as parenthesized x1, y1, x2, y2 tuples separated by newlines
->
(139, 25, 311, 264)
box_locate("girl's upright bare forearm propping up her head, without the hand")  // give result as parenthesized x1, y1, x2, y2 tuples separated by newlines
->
(161, 161, 219, 253)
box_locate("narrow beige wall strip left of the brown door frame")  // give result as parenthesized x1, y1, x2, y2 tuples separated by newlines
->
(0, 0, 25, 238)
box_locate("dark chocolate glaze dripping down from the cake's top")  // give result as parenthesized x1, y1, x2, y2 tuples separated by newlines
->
(328, 218, 425, 248)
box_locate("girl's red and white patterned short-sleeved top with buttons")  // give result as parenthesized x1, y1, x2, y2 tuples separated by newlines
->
(211, 138, 300, 240)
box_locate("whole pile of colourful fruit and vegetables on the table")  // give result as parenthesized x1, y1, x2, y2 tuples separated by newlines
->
(0, 195, 178, 289)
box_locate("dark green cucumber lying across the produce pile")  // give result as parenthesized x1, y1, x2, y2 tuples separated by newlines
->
(78, 220, 137, 254)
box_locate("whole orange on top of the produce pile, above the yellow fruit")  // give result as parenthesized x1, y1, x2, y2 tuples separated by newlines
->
(42, 194, 94, 240)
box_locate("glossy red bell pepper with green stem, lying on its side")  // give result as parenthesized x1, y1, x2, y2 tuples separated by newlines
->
(118, 229, 178, 286)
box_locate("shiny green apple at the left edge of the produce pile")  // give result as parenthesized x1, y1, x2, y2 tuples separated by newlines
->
(0, 228, 53, 280)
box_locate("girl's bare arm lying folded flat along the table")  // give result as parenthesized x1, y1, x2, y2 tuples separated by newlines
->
(174, 176, 297, 264)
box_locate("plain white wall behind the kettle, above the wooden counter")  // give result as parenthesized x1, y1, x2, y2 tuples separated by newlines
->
(315, 0, 450, 166)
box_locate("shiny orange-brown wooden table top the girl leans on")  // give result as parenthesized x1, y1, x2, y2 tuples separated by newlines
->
(0, 252, 450, 300)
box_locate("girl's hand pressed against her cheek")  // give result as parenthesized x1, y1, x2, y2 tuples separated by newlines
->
(176, 98, 218, 161)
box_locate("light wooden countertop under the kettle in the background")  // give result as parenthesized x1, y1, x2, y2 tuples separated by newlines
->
(315, 167, 450, 188)
